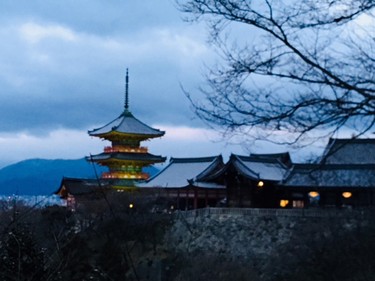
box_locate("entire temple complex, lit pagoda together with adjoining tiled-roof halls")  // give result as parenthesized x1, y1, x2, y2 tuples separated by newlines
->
(55, 71, 375, 210)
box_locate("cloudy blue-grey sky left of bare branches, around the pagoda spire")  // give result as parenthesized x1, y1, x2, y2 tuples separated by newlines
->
(0, 0, 324, 167)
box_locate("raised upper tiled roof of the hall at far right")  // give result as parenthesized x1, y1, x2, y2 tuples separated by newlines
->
(321, 139, 375, 164)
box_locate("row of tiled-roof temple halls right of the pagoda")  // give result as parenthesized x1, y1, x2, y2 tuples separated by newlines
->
(140, 139, 375, 209)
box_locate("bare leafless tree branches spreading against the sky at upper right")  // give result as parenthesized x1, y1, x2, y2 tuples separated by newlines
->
(176, 0, 375, 144)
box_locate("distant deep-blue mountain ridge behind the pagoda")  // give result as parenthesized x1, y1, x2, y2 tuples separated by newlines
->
(0, 158, 158, 195)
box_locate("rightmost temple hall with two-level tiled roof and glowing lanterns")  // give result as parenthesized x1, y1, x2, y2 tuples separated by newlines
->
(278, 139, 375, 208)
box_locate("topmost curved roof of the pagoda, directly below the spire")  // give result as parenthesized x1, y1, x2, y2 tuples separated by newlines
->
(88, 109, 165, 138)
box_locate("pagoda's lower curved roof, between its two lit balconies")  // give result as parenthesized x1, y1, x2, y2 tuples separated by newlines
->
(86, 152, 165, 163)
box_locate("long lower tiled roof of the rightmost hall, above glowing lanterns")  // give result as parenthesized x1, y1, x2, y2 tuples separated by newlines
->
(280, 164, 375, 188)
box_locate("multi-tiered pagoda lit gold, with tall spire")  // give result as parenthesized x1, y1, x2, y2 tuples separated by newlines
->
(87, 70, 165, 188)
